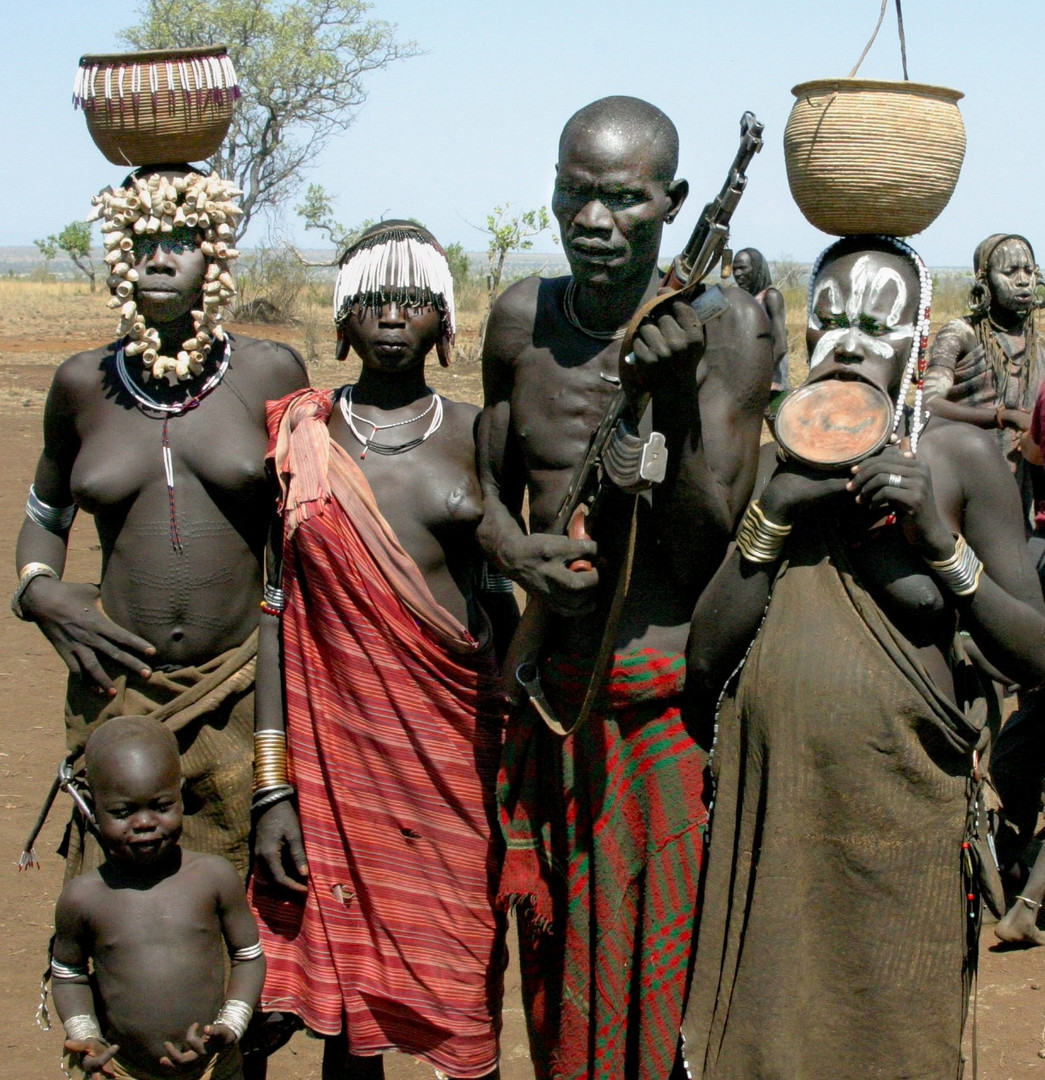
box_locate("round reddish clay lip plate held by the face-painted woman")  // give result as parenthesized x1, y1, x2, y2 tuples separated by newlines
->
(774, 379, 893, 469)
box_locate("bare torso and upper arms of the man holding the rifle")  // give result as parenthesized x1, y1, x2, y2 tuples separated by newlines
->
(480, 273, 769, 652)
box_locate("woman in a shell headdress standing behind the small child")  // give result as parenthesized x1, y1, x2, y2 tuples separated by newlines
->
(12, 159, 308, 875)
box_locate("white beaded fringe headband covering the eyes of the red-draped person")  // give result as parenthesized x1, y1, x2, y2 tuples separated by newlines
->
(334, 221, 457, 367)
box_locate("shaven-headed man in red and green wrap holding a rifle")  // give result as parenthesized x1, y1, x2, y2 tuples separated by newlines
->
(479, 97, 772, 1080)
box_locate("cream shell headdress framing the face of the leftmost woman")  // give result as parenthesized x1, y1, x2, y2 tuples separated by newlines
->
(87, 172, 243, 381)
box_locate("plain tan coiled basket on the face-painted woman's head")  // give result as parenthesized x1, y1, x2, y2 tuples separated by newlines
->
(784, 79, 965, 237)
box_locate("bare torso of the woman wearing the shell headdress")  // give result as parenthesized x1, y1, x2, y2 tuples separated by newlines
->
(18, 336, 307, 675)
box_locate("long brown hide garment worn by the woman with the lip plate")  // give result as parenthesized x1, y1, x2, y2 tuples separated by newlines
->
(683, 525, 986, 1080)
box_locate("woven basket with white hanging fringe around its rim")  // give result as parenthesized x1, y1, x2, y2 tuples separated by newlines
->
(72, 45, 240, 165)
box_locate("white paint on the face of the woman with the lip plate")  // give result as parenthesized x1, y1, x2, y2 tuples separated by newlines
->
(809, 253, 914, 369)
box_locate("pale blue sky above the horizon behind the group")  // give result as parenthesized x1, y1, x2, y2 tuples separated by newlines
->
(0, 0, 1045, 267)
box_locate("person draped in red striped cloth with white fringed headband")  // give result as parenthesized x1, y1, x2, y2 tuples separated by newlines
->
(253, 221, 515, 1080)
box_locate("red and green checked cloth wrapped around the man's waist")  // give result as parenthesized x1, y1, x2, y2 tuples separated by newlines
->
(498, 649, 707, 1080)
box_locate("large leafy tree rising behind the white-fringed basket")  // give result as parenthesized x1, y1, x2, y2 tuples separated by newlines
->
(122, 0, 418, 237)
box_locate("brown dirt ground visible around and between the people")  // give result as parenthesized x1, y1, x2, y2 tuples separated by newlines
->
(0, 283, 1045, 1080)
